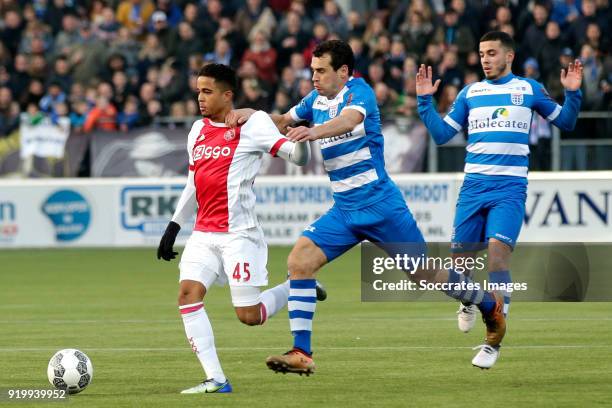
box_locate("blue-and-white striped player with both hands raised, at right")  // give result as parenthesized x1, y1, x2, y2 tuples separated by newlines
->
(416, 31, 582, 368)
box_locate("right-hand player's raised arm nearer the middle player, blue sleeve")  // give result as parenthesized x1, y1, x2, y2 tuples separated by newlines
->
(416, 64, 467, 145)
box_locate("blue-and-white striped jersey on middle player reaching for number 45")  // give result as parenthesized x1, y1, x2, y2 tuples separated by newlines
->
(289, 77, 397, 210)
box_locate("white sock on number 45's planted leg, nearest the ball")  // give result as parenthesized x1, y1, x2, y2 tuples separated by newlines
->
(179, 302, 226, 383)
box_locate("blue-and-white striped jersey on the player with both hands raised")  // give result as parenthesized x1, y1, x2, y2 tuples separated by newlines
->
(418, 74, 581, 179)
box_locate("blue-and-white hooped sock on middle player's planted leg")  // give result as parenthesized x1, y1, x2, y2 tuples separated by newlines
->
(287, 279, 317, 354)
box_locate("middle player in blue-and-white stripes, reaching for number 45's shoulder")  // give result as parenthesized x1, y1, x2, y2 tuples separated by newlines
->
(231, 40, 505, 375)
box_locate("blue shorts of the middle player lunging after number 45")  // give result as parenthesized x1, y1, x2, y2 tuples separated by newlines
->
(302, 191, 426, 262)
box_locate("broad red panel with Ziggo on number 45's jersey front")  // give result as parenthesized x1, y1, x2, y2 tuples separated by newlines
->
(192, 121, 240, 232)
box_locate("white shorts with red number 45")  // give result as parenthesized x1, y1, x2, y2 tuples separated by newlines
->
(179, 227, 268, 307)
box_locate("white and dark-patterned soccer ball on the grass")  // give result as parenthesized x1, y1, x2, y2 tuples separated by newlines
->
(47, 349, 93, 394)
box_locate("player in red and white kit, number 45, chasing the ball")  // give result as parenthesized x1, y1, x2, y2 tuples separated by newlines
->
(157, 64, 310, 394)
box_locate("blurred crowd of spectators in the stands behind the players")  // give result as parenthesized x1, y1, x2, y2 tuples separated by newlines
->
(0, 0, 612, 137)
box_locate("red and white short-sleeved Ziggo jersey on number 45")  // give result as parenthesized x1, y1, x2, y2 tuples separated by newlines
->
(187, 111, 287, 232)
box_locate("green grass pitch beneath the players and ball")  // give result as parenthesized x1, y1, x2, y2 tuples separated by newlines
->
(0, 248, 612, 408)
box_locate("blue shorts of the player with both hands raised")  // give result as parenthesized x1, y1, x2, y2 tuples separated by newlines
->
(451, 179, 527, 252)
